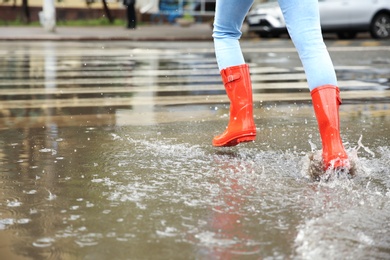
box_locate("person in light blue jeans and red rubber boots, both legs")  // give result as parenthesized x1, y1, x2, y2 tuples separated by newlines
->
(213, 0, 350, 173)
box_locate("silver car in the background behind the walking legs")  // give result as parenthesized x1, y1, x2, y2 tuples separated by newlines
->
(246, 0, 390, 39)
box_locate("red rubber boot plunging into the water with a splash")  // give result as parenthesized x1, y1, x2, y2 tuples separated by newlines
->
(311, 85, 350, 170)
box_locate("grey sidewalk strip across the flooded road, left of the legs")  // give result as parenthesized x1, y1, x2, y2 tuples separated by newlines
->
(0, 23, 225, 41)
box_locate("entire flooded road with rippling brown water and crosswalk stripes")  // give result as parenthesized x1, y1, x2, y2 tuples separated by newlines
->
(0, 40, 390, 259)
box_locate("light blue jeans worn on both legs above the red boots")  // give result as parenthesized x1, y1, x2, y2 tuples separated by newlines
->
(213, 0, 337, 90)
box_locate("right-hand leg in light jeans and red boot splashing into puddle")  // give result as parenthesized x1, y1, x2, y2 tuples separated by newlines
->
(279, 0, 350, 169)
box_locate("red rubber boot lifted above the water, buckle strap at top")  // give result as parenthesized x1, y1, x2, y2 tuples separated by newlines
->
(213, 64, 256, 146)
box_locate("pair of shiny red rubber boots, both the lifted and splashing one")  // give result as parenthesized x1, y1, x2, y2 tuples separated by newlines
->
(213, 64, 349, 169)
